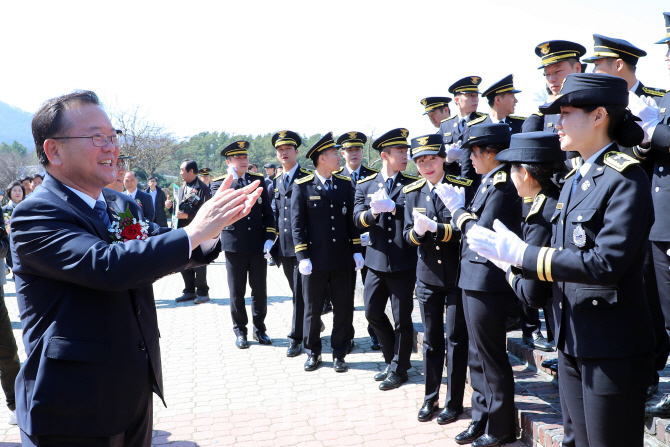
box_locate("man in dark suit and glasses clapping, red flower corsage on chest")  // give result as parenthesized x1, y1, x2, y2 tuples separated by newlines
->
(11, 91, 260, 447)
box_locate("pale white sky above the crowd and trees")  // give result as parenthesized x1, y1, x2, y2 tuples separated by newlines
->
(0, 0, 670, 142)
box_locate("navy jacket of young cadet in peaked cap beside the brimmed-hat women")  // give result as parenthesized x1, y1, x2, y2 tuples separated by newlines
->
(403, 174, 472, 287)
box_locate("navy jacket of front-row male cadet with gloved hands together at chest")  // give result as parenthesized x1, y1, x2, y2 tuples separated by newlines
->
(354, 172, 417, 273)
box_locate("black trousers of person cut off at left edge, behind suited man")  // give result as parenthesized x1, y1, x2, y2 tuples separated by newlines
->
(0, 286, 21, 410)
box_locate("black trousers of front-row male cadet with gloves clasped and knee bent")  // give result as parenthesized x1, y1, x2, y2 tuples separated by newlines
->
(363, 269, 416, 374)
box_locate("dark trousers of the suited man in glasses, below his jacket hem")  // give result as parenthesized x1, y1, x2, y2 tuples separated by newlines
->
(21, 374, 153, 447)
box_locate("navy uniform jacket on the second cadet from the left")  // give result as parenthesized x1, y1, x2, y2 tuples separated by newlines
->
(271, 166, 312, 258)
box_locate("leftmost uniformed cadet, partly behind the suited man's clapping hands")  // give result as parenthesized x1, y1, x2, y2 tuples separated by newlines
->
(211, 140, 277, 349)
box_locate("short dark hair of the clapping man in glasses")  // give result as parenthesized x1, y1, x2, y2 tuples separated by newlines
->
(32, 90, 100, 166)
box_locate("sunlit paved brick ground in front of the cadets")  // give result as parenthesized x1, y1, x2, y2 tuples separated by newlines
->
(0, 263, 523, 447)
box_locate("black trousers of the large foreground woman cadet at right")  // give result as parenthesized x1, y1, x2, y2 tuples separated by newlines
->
(558, 351, 653, 447)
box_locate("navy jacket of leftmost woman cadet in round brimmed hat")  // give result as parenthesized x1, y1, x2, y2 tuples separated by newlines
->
(453, 163, 522, 293)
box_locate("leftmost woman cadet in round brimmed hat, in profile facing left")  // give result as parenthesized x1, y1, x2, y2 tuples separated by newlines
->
(436, 123, 521, 447)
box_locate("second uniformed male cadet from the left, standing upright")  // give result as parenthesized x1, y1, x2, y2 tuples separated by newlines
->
(272, 130, 311, 357)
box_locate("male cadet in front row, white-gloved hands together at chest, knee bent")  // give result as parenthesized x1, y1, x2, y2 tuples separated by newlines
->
(354, 128, 417, 390)
